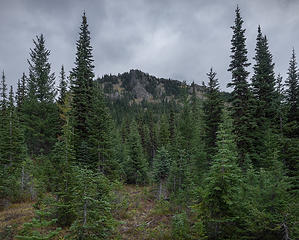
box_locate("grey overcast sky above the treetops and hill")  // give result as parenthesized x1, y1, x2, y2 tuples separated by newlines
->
(0, 0, 299, 89)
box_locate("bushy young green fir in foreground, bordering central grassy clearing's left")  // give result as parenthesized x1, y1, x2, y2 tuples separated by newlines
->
(70, 167, 114, 239)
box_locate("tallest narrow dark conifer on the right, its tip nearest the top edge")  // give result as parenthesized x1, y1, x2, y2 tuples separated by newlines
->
(228, 7, 252, 165)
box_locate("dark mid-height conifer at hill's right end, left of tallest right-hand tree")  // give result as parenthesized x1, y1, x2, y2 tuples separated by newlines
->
(203, 68, 223, 159)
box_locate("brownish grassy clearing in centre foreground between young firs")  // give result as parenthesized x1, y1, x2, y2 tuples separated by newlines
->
(115, 185, 172, 240)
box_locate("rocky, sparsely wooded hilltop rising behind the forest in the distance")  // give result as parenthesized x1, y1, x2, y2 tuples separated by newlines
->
(97, 70, 205, 103)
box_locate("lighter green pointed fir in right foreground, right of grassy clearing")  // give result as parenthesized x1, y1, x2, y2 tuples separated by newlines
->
(200, 112, 242, 239)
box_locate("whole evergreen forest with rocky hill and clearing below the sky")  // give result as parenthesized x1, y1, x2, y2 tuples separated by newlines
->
(0, 7, 299, 240)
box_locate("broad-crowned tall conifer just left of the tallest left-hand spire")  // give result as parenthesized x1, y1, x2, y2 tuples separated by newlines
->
(22, 34, 59, 155)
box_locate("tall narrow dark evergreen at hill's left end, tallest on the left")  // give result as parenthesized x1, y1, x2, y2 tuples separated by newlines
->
(70, 12, 94, 161)
